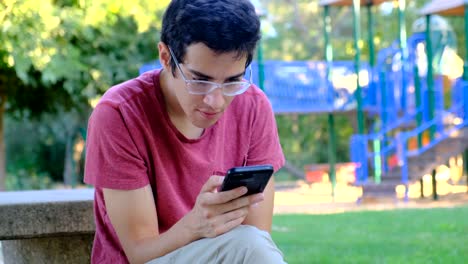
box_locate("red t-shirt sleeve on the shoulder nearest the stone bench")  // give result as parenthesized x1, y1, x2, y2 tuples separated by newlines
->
(84, 104, 149, 190)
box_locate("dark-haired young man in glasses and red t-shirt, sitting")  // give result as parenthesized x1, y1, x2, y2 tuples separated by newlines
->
(85, 0, 284, 263)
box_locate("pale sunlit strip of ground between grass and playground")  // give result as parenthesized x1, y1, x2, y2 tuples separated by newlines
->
(274, 182, 468, 214)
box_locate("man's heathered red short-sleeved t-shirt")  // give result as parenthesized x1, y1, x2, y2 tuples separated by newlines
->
(85, 70, 284, 263)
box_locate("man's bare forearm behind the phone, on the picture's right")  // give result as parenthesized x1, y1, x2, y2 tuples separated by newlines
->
(243, 176, 275, 232)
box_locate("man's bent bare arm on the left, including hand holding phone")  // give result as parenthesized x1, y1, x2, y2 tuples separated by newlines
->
(103, 176, 263, 263)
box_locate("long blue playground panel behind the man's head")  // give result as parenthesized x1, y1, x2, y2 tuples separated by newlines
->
(140, 60, 369, 114)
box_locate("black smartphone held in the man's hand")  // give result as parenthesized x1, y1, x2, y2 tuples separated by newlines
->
(220, 164, 273, 195)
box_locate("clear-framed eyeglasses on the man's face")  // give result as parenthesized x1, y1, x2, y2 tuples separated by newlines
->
(167, 46, 252, 96)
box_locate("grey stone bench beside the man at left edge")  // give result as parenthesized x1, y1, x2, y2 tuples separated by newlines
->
(0, 189, 95, 264)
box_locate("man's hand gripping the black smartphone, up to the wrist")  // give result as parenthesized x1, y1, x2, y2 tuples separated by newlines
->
(182, 176, 263, 239)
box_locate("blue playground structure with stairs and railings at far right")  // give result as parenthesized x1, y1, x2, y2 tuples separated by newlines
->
(351, 1, 468, 199)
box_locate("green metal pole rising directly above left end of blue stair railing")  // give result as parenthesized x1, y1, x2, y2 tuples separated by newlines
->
(353, 0, 365, 134)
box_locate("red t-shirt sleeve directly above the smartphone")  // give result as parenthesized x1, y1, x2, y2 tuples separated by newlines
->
(247, 92, 285, 172)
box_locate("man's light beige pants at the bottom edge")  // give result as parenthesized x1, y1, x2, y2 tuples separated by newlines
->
(148, 225, 285, 264)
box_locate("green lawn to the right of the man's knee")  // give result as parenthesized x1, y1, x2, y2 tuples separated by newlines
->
(272, 207, 468, 264)
